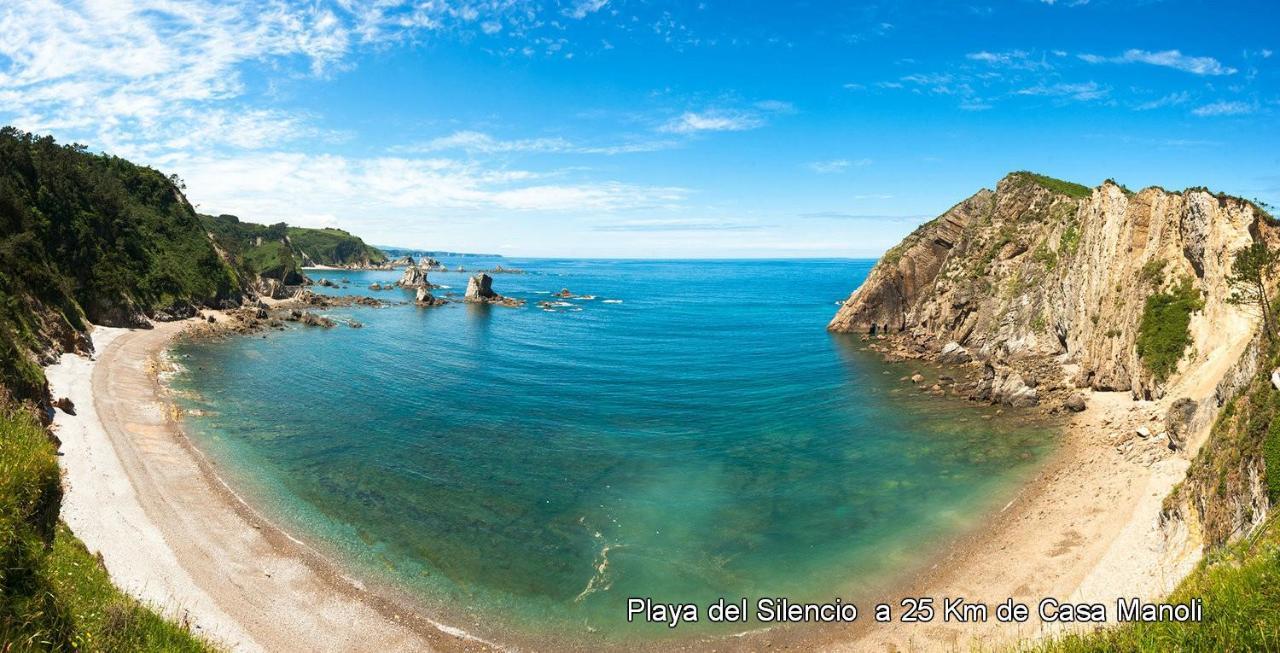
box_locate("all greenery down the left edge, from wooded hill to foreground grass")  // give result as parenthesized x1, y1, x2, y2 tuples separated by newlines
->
(0, 127, 241, 652)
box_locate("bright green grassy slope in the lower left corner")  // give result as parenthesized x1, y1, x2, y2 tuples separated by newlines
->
(0, 407, 214, 653)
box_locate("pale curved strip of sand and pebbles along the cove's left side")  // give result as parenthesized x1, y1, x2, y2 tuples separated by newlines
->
(46, 320, 500, 652)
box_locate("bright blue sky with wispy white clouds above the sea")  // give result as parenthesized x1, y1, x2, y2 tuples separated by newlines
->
(0, 0, 1280, 257)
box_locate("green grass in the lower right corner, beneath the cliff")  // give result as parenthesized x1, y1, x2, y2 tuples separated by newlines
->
(1032, 516, 1280, 653)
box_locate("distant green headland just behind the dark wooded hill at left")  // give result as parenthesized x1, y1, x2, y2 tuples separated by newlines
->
(200, 215, 387, 286)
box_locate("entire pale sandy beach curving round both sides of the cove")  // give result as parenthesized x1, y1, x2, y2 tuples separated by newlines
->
(47, 314, 1238, 650)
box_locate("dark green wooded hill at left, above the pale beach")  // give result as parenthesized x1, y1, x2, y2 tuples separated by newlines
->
(0, 127, 239, 401)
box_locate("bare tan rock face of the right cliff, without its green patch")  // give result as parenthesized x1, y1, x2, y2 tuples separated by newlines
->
(828, 173, 1274, 397)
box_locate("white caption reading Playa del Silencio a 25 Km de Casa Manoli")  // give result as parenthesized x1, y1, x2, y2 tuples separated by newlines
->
(627, 597, 1204, 627)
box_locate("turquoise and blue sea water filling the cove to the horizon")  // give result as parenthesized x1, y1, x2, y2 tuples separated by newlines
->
(167, 259, 1052, 641)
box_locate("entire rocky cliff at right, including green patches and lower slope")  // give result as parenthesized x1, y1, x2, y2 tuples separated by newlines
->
(828, 173, 1280, 555)
